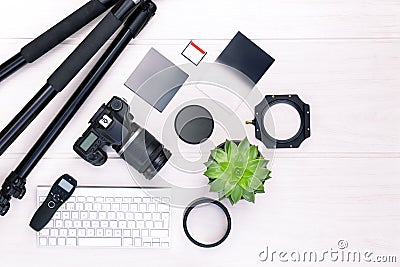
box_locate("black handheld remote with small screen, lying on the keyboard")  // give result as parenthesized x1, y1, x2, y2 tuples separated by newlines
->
(29, 174, 77, 232)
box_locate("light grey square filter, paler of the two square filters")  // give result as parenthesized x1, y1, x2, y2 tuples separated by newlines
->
(125, 48, 189, 112)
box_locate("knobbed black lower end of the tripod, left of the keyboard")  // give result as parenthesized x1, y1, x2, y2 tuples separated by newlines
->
(0, 172, 26, 216)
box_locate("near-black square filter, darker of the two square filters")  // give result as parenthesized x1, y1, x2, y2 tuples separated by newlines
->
(216, 32, 275, 84)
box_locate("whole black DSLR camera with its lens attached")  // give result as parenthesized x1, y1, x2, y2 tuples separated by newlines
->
(74, 96, 171, 180)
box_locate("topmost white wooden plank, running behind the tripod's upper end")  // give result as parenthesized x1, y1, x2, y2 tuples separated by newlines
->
(0, 0, 400, 41)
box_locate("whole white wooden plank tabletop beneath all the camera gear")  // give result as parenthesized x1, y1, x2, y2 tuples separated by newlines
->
(0, 0, 400, 267)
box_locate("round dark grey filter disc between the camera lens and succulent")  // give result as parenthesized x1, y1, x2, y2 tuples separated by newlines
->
(175, 105, 214, 145)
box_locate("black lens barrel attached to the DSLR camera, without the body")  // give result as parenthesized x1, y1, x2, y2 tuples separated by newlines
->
(117, 123, 171, 180)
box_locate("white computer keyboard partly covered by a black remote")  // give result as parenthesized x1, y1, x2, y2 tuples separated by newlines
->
(37, 186, 171, 248)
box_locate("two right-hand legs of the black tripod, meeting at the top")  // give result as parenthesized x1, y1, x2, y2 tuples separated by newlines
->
(0, 0, 156, 216)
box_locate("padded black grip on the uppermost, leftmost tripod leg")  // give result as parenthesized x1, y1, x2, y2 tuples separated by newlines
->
(21, 0, 117, 63)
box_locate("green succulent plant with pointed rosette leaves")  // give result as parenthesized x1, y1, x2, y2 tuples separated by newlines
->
(204, 138, 271, 205)
